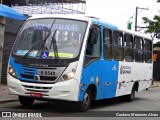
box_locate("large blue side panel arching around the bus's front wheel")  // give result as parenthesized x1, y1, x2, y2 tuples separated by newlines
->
(79, 60, 119, 101)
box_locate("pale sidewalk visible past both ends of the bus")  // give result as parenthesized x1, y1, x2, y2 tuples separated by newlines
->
(0, 81, 160, 103)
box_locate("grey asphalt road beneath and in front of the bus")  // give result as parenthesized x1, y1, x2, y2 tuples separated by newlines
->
(0, 87, 160, 120)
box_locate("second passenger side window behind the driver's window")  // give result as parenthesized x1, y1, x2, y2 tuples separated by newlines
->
(113, 31, 124, 61)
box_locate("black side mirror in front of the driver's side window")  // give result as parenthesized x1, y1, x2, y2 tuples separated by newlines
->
(89, 28, 99, 44)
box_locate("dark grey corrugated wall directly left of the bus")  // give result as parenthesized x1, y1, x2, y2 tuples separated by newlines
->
(1, 18, 24, 84)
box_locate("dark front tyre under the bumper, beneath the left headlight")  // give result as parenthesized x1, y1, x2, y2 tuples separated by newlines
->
(19, 96, 34, 106)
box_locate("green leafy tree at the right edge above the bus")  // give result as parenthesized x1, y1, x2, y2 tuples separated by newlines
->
(142, 0, 160, 36)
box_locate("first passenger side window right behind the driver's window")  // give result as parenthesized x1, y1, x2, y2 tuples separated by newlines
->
(103, 28, 112, 60)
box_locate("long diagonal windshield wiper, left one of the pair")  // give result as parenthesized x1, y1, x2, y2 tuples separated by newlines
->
(23, 19, 56, 57)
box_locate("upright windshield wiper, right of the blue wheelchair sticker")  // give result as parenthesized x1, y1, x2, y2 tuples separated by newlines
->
(50, 29, 59, 60)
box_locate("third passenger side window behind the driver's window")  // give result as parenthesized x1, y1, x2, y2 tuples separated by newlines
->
(124, 34, 134, 62)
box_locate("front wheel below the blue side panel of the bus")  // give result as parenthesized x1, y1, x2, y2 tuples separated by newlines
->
(78, 89, 91, 112)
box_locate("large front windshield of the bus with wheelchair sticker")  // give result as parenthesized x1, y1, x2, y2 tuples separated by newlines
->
(13, 19, 87, 59)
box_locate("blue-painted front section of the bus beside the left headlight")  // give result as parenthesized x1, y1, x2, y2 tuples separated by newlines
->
(9, 57, 38, 82)
